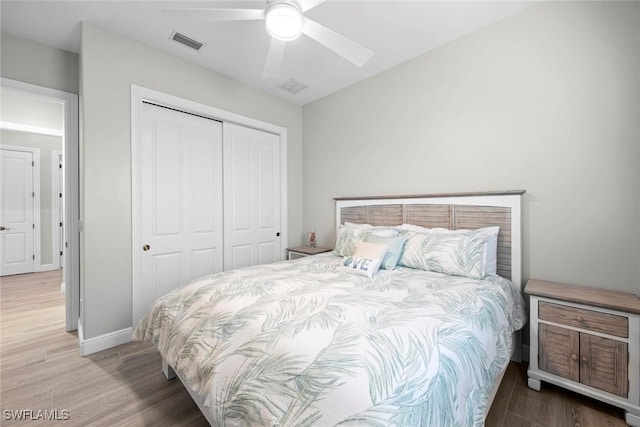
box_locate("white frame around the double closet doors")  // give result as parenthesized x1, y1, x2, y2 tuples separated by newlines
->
(131, 85, 288, 326)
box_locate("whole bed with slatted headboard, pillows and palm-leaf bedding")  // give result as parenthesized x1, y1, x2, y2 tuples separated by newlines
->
(134, 191, 526, 426)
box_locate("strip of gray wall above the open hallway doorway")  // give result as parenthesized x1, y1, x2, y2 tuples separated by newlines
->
(0, 33, 78, 93)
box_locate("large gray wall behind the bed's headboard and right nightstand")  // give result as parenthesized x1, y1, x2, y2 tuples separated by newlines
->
(304, 2, 640, 292)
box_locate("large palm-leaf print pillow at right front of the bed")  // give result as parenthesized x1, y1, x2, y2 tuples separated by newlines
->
(399, 230, 488, 279)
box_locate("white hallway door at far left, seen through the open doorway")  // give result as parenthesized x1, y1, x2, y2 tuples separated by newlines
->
(0, 148, 35, 276)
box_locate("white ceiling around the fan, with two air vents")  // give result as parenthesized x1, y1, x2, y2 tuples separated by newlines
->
(0, 0, 535, 105)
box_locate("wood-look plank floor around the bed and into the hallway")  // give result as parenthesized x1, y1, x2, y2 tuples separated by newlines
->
(0, 271, 626, 427)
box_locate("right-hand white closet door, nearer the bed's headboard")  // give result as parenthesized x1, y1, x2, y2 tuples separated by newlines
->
(223, 123, 282, 270)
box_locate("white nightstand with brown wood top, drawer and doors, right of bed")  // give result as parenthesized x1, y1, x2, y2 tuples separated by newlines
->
(524, 280, 640, 427)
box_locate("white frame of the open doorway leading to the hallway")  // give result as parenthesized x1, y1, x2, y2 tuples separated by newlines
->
(0, 77, 82, 332)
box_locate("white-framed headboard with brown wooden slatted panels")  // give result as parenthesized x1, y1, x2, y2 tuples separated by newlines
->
(335, 190, 524, 288)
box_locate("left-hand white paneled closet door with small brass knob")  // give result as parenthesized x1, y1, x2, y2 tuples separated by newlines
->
(139, 103, 223, 320)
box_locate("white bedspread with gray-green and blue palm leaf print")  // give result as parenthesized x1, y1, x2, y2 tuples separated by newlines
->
(134, 253, 525, 427)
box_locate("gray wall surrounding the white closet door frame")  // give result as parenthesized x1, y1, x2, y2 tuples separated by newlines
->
(80, 23, 303, 338)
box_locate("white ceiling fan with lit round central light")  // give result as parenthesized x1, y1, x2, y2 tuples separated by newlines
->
(162, 0, 373, 79)
